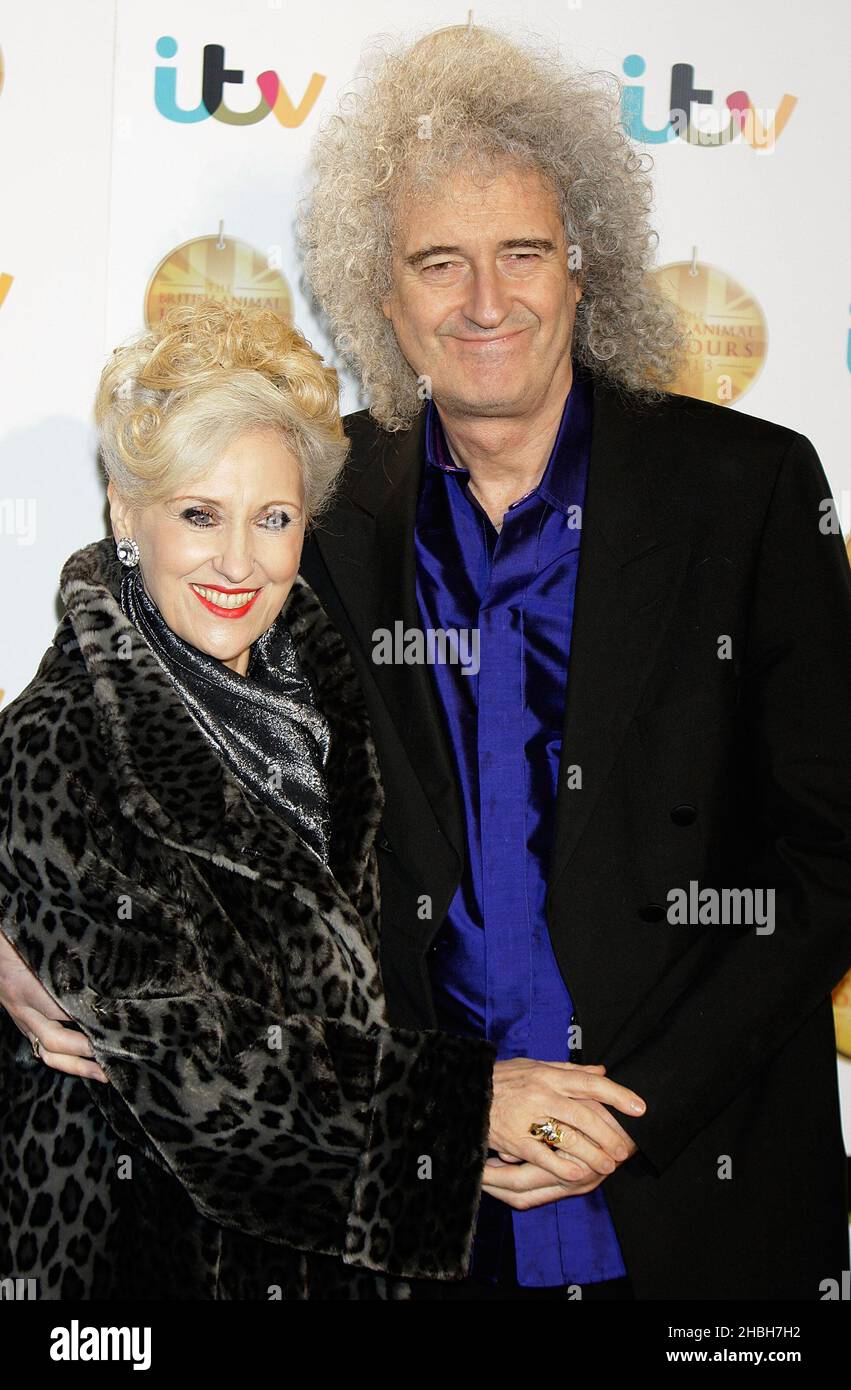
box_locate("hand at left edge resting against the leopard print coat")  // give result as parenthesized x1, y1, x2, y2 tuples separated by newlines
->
(0, 931, 108, 1084)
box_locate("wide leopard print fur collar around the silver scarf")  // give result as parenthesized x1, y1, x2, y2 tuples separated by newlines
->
(57, 538, 384, 928)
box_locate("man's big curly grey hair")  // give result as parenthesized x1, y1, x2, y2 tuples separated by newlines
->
(298, 25, 688, 431)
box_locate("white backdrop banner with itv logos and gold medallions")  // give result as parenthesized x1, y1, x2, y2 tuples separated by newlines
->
(0, 0, 851, 1173)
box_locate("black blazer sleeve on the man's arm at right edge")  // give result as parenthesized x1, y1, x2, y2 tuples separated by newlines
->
(606, 435, 851, 1173)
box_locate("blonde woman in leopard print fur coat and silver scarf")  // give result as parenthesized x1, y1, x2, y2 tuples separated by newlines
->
(0, 302, 495, 1298)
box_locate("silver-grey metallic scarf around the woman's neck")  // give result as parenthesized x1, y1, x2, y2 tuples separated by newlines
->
(121, 566, 331, 865)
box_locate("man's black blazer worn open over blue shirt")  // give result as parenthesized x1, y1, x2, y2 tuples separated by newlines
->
(302, 378, 851, 1300)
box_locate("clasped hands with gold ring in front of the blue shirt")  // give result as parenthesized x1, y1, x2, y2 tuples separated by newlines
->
(483, 1058, 647, 1209)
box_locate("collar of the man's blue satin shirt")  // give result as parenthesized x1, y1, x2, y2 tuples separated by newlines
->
(426, 359, 592, 512)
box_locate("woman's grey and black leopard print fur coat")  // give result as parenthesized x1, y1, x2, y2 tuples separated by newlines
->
(0, 538, 495, 1300)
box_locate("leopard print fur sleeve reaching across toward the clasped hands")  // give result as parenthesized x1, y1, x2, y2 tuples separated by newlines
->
(0, 811, 495, 1279)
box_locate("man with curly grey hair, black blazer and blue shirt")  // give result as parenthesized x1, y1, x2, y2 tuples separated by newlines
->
(1, 28, 851, 1300)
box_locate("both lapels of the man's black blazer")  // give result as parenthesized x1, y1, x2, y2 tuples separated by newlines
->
(316, 375, 691, 894)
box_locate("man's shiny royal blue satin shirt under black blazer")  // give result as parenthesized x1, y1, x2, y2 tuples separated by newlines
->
(414, 361, 626, 1286)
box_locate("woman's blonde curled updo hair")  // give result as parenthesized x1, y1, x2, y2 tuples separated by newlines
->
(95, 299, 349, 521)
